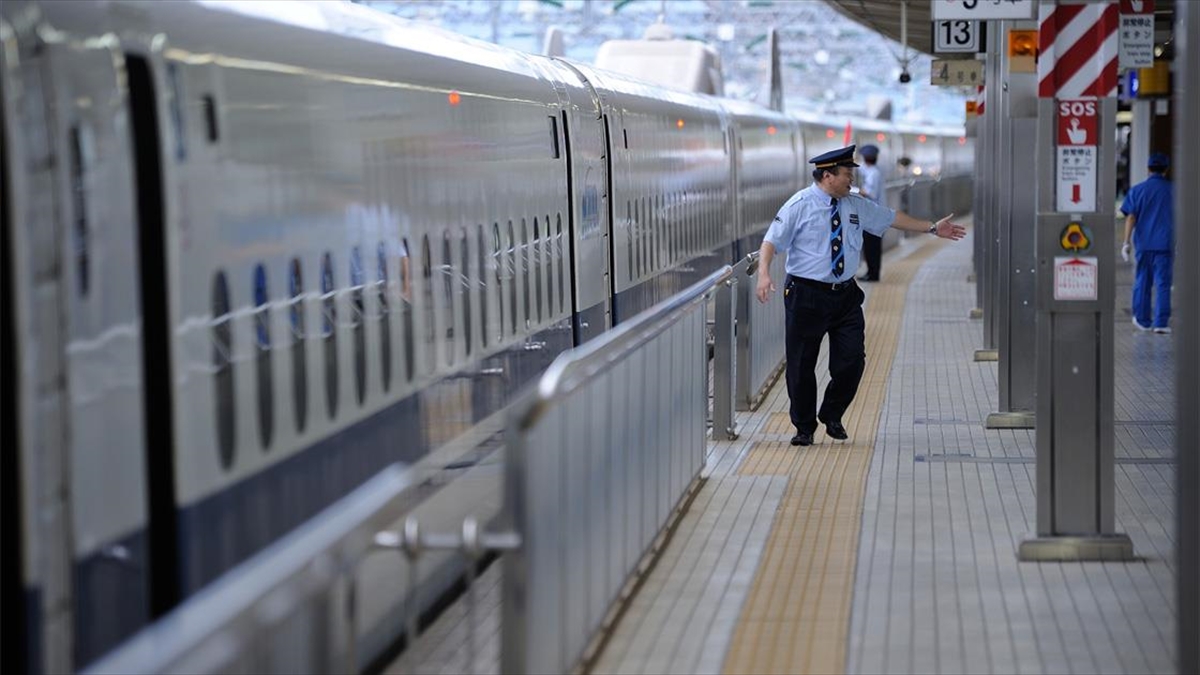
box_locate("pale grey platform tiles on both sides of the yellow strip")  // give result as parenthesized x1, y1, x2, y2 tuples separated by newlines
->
(389, 218, 1176, 673)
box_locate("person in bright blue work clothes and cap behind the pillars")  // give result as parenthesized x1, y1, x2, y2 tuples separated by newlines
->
(1121, 153, 1175, 334)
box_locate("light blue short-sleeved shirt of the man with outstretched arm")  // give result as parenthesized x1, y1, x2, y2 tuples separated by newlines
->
(764, 184, 896, 283)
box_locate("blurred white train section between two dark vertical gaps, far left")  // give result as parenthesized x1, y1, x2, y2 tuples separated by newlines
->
(5, 20, 166, 671)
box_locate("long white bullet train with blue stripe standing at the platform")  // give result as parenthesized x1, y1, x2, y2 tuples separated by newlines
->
(0, 0, 972, 673)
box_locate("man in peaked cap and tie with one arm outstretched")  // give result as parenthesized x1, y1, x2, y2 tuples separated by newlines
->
(755, 145, 966, 446)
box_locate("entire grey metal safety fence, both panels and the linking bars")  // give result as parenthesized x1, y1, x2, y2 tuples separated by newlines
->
(86, 256, 758, 674)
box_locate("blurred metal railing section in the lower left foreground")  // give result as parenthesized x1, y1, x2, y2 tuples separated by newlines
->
(86, 465, 427, 674)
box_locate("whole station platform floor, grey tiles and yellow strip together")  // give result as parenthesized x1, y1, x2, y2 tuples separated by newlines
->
(389, 218, 1176, 673)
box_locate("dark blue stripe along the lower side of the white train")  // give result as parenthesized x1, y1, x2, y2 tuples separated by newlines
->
(71, 312, 580, 665)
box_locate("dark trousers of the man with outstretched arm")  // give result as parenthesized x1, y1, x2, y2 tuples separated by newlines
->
(784, 276, 866, 434)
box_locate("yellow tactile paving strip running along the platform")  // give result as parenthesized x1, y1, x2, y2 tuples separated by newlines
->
(725, 235, 944, 674)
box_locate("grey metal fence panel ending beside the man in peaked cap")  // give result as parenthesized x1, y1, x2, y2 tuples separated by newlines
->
(502, 256, 756, 673)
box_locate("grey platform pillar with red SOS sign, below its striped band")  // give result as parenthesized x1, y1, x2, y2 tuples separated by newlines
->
(1018, 89, 1133, 560)
